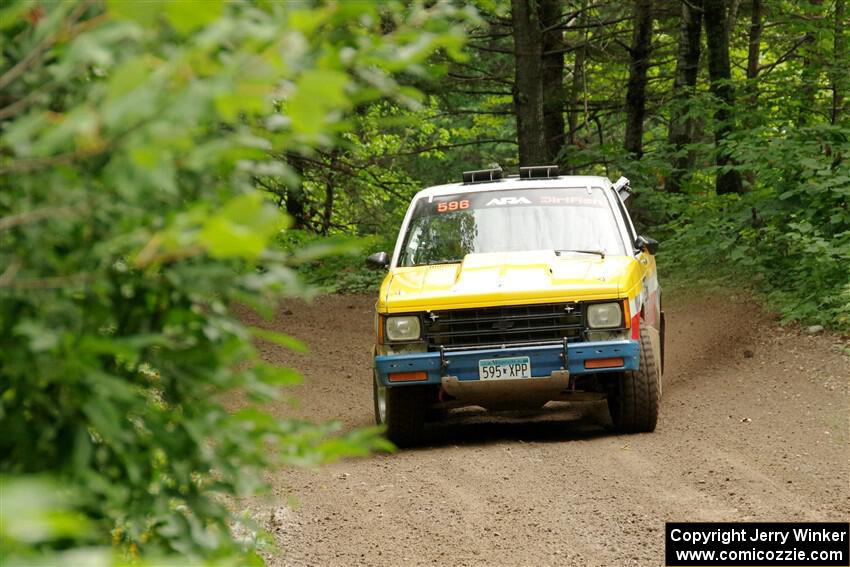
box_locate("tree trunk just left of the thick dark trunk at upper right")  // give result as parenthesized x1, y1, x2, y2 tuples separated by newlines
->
(666, 0, 702, 193)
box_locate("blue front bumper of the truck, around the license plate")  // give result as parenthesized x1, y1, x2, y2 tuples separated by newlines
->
(375, 340, 640, 386)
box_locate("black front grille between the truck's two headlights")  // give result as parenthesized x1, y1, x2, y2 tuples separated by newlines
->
(423, 303, 584, 348)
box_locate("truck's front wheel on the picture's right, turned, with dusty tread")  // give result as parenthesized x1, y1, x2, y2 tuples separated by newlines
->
(608, 321, 661, 433)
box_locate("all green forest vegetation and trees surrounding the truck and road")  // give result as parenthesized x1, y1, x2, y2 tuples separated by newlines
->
(0, 0, 850, 565)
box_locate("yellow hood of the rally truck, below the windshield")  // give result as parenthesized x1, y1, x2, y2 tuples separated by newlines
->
(378, 251, 640, 313)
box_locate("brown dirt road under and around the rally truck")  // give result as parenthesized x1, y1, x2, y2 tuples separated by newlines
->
(240, 297, 850, 566)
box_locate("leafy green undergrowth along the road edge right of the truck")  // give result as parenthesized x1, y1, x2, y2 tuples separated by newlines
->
(639, 125, 850, 330)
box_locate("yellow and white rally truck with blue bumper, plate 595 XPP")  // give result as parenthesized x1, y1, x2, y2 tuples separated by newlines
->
(367, 166, 664, 446)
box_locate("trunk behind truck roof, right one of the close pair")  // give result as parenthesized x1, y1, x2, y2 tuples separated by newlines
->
(540, 0, 565, 163)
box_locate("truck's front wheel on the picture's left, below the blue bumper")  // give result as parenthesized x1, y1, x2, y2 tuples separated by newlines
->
(373, 376, 428, 447)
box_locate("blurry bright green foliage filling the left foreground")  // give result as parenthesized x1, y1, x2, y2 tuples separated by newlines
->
(0, 0, 465, 563)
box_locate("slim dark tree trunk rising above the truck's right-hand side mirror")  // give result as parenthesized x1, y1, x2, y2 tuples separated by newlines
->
(623, 0, 652, 159)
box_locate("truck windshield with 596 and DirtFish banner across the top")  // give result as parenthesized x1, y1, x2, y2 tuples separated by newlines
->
(399, 187, 625, 266)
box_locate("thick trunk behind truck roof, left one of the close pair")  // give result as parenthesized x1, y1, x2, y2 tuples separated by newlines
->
(511, 0, 547, 166)
